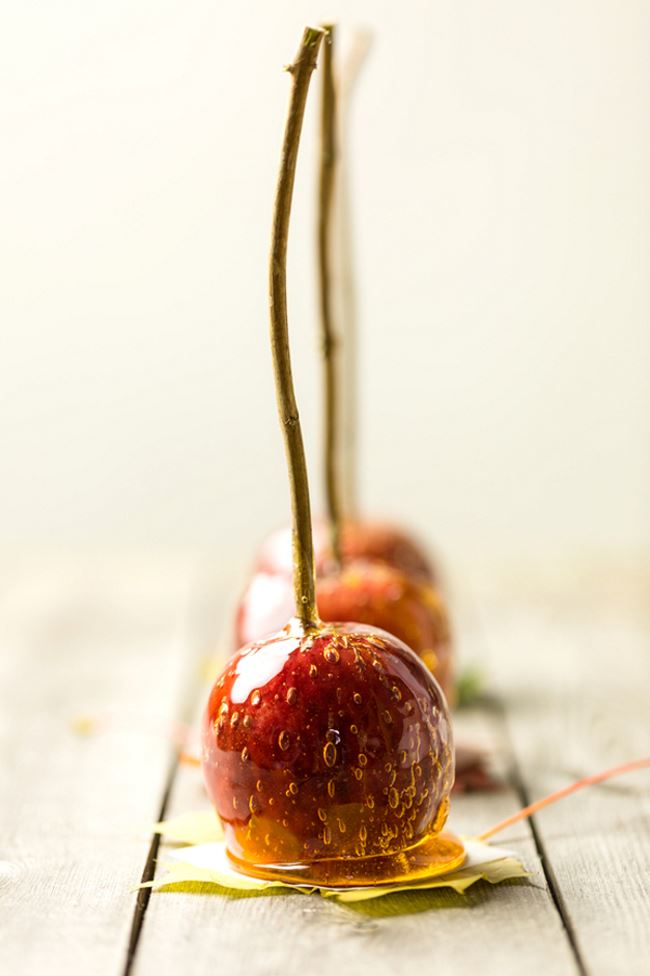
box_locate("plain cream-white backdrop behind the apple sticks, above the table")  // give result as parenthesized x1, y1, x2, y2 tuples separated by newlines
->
(0, 0, 650, 570)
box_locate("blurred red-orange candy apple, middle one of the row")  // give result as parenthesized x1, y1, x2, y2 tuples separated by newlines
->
(234, 561, 454, 704)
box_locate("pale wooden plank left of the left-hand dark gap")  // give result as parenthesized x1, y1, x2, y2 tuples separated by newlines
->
(0, 559, 191, 976)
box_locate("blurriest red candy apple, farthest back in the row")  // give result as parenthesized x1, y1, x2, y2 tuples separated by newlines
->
(254, 520, 434, 583)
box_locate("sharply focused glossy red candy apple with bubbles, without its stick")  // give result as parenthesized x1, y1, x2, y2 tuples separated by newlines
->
(202, 623, 456, 885)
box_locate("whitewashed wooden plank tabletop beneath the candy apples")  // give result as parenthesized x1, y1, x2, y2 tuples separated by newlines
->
(0, 555, 650, 976)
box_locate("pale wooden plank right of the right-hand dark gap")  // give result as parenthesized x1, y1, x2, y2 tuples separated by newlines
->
(476, 567, 650, 976)
